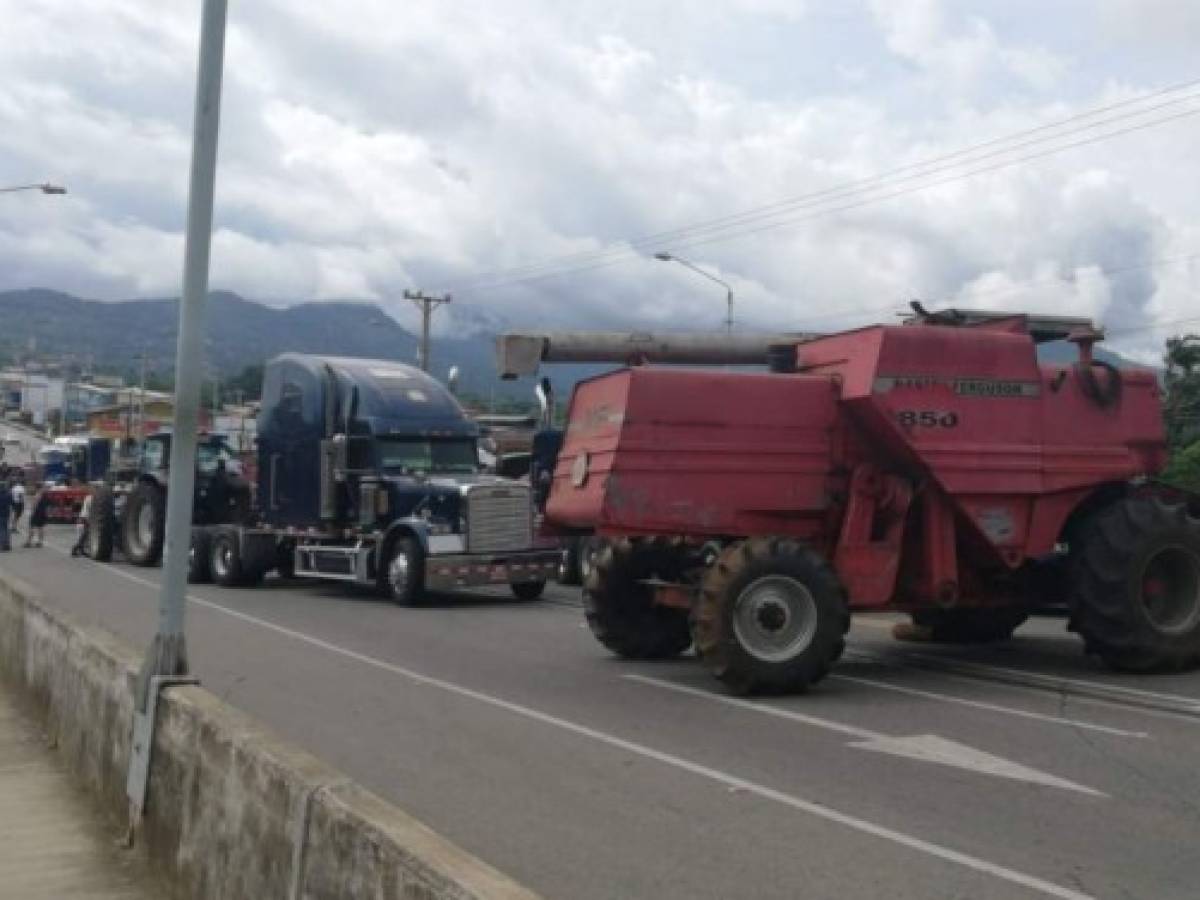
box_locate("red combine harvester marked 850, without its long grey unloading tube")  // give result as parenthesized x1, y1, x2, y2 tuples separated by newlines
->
(525, 307, 1200, 692)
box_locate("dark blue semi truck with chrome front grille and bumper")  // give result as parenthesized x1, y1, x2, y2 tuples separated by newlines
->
(180, 353, 559, 605)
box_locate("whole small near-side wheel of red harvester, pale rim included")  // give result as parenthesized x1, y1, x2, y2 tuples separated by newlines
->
(692, 538, 850, 694)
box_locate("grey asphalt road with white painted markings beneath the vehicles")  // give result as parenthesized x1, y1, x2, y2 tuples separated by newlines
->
(0, 530, 1200, 900)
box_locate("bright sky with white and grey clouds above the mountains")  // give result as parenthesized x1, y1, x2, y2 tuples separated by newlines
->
(0, 0, 1200, 358)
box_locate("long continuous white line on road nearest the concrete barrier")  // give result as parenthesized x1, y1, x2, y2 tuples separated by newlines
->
(30, 547, 1096, 900)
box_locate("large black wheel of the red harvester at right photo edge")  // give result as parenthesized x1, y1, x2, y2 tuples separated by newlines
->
(1070, 497, 1200, 672)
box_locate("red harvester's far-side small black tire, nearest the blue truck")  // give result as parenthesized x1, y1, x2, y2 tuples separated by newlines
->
(583, 539, 691, 659)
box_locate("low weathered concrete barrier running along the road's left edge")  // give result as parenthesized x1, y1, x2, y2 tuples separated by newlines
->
(0, 571, 535, 900)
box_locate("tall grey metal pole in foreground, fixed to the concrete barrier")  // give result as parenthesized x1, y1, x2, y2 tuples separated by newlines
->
(139, 0, 228, 696)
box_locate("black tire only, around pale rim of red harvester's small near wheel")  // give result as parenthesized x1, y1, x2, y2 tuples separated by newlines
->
(692, 538, 850, 694)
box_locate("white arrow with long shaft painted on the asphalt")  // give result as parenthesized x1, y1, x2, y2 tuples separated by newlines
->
(623, 673, 1108, 797)
